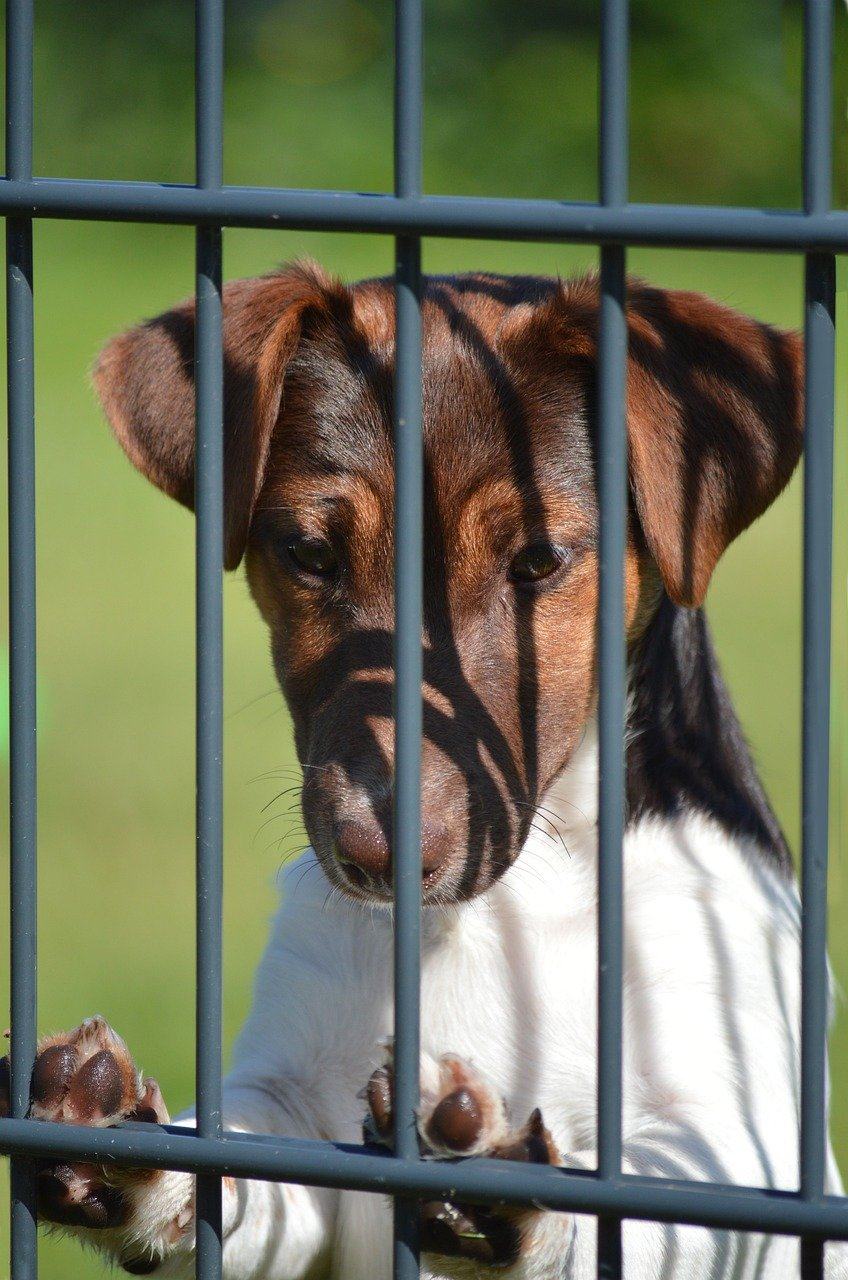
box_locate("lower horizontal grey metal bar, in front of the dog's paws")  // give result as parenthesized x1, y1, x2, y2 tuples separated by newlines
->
(0, 1119, 848, 1240)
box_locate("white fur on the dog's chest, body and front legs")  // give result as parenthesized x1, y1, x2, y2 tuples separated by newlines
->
(74, 730, 848, 1280)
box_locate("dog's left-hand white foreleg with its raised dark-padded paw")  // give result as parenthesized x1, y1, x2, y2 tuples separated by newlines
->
(8, 1018, 337, 1280)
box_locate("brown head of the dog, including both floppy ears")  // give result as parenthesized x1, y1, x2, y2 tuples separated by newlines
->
(96, 268, 801, 901)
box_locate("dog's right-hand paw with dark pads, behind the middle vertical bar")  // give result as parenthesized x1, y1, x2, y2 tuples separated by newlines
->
(364, 1053, 560, 1267)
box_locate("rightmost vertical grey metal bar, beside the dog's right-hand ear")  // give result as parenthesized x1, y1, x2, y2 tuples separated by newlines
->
(801, 0, 836, 1280)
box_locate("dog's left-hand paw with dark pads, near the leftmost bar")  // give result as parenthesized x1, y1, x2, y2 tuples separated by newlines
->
(0, 1018, 192, 1275)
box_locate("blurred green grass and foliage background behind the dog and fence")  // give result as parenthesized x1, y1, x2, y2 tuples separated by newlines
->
(0, 0, 848, 1280)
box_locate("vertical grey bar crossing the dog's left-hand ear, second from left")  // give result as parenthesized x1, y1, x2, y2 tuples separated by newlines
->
(195, 0, 224, 1280)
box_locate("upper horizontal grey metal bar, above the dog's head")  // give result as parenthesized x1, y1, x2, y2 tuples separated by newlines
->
(0, 178, 848, 252)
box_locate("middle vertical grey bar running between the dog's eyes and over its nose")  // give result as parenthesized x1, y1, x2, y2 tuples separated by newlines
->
(392, 0, 424, 1280)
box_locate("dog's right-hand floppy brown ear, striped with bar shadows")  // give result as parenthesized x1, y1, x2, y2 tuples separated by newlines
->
(522, 278, 803, 605)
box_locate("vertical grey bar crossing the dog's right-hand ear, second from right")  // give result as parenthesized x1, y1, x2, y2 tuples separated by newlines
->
(597, 0, 629, 1280)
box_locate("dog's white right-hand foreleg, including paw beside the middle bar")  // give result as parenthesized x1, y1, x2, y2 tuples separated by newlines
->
(365, 1055, 847, 1280)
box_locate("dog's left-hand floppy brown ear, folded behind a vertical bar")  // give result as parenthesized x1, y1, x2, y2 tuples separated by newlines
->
(94, 264, 347, 568)
